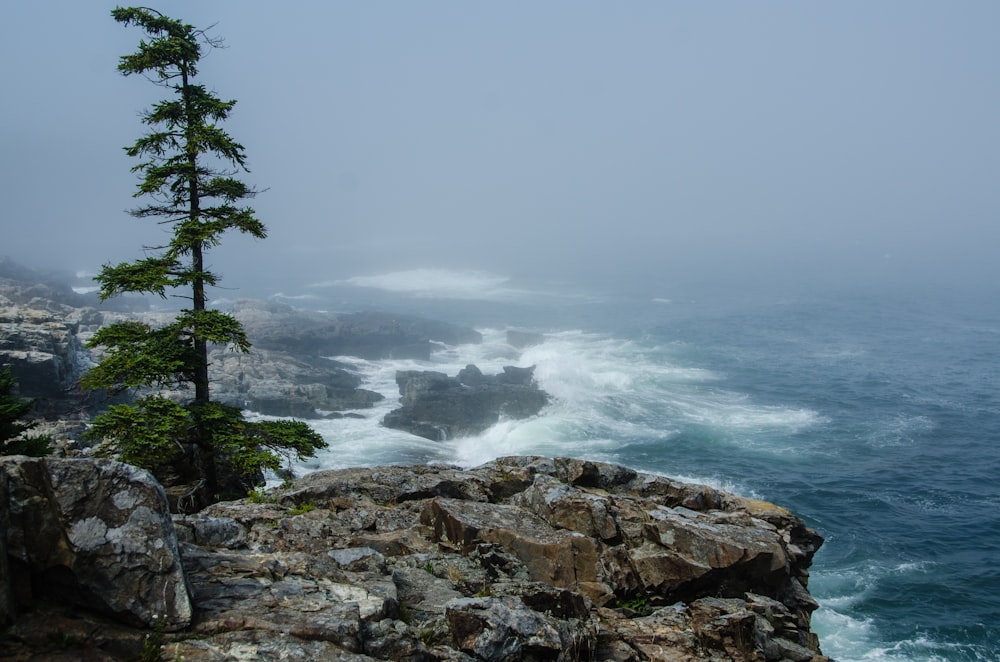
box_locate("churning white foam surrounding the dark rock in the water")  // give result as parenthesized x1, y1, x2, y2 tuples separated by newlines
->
(278, 320, 818, 482)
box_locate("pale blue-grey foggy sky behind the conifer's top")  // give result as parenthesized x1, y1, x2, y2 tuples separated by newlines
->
(0, 0, 1000, 300)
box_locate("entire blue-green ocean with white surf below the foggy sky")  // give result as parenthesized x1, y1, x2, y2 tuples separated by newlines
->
(266, 279, 1000, 661)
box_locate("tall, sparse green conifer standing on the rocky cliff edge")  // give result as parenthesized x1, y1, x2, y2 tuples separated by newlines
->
(82, 7, 326, 504)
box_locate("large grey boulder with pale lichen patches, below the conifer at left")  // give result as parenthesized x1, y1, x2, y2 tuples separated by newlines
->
(0, 457, 192, 630)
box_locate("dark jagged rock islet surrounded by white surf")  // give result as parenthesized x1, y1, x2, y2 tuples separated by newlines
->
(382, 365, 549, 441)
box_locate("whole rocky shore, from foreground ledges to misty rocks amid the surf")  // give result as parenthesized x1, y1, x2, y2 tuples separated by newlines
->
(0, 259, 827, 662)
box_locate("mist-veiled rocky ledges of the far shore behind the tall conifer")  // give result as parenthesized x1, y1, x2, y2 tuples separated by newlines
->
(0, 259, 482, 421)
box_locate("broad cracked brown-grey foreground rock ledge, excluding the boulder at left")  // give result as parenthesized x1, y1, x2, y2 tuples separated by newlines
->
(4, 457, 826, 662)
